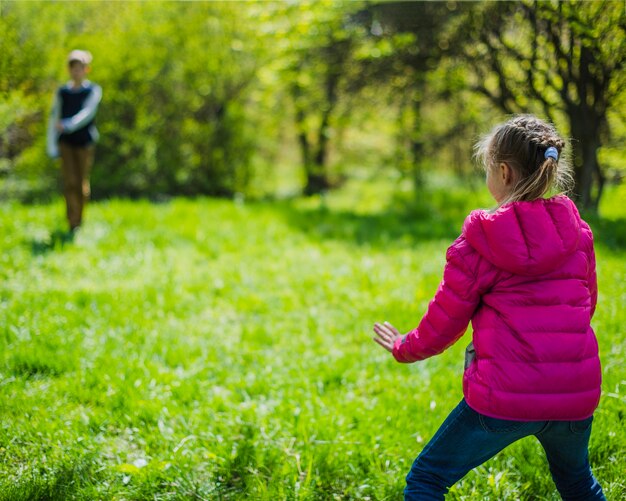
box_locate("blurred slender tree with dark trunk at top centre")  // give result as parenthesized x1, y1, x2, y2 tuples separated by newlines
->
(274, 1, 362, 195)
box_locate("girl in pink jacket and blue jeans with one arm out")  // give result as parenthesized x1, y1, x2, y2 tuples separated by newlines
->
(374, 115, 605, 501)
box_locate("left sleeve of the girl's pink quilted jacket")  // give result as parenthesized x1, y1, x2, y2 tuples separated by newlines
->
(393, 237, 481, 363)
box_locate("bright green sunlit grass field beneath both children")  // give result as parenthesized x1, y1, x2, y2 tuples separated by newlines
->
(0, 178, 626, 501)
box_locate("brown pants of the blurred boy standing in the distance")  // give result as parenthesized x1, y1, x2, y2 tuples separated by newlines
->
(59, 143, 94, 230)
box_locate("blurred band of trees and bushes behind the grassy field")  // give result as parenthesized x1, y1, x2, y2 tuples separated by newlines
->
(0, 0, 626, 211)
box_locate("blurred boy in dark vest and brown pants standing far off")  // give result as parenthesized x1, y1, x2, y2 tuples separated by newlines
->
(47, 50, 102, 234)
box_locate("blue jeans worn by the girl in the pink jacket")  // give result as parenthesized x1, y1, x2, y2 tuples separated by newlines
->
(404, 400, 606, 501)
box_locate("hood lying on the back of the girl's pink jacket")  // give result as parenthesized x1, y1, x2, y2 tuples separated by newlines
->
(463, 195, 581, 276)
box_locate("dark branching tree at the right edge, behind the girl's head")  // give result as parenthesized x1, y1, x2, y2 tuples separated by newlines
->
(455, 0, 626, 210)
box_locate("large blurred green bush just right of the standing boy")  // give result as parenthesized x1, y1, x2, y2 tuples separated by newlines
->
(85, 3, 256, 195)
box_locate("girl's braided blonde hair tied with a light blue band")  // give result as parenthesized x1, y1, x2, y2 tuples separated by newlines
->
(475, 115, 573, 205)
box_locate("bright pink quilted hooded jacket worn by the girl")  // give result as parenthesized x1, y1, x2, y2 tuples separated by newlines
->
(393, 196, 601, 421)
